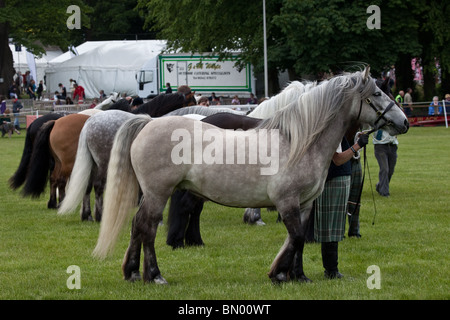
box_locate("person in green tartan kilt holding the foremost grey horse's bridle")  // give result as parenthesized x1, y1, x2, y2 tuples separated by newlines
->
(314, 134, 369, 279)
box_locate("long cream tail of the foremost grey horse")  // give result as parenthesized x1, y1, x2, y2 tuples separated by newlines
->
(93, 115, 151, 258)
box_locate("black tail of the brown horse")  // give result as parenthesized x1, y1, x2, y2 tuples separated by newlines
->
(22, 120, 55, 198)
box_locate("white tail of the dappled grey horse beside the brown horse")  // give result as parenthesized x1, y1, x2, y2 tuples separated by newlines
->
(58, 127, 94, 214)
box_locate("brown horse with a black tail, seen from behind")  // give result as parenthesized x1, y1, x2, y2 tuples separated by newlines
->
(22, 114, 89, 215)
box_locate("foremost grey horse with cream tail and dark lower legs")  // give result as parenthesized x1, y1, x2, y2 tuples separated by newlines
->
(94, 68, 409, 284)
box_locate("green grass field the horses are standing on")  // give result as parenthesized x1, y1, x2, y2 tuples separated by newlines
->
(0, 127, 450, 300)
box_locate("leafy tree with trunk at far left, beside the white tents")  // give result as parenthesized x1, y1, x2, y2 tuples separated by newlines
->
(0, 0, 91, 95)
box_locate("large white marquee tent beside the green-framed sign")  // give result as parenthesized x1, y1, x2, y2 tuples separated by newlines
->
(45, 40, 166, 98)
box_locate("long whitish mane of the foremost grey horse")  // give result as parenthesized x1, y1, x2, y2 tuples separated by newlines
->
(259, 71, 376, 164)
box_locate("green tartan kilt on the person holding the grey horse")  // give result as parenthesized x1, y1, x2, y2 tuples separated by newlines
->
(314, 176, 351, 242)
